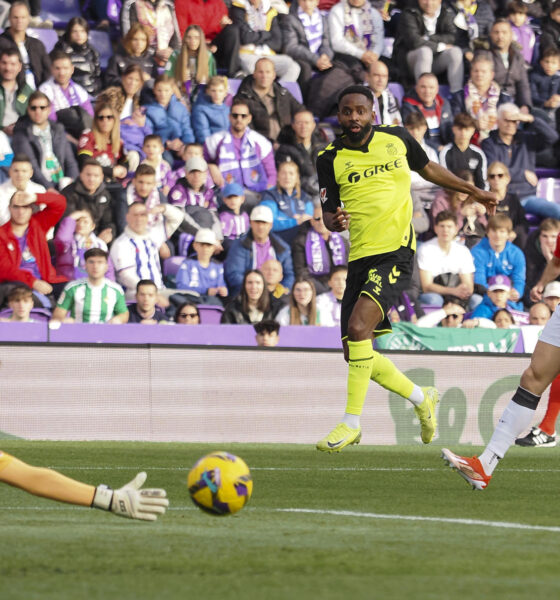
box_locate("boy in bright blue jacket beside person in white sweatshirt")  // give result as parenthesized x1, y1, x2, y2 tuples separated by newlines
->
(471, 214, 525, 310)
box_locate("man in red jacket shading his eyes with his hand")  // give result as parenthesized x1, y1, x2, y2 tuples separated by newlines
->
(0, 192, 67, 303)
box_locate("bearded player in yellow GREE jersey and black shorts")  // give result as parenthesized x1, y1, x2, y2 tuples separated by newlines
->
(317, 85, 497, 452)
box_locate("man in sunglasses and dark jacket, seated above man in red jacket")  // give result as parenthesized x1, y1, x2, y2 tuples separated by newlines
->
(12, 91, 80, 190)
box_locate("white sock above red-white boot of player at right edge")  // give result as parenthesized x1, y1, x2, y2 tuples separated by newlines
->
(478, 400, 536, 475)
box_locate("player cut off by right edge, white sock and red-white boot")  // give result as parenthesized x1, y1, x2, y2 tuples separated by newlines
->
(441, 234, 560, 490)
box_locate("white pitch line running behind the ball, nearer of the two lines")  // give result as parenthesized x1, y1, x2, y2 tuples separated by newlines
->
(4, 506, 560, 533)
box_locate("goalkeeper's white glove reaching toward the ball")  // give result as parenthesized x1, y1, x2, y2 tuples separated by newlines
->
(92, 472, 169, 521)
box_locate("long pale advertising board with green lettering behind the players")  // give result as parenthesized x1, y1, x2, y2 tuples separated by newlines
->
(0, 345, 548, 445)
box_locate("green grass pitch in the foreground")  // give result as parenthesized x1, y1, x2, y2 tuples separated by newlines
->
(0, 440, 560, 600)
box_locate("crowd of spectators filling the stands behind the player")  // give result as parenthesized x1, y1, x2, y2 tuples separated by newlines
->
(0, 0, 560, 343)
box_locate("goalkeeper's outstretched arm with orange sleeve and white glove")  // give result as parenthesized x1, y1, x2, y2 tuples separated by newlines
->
(0, 450, 169, 521)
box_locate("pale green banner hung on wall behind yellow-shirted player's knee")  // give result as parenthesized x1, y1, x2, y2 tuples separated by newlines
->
(375, 323, 519, 353)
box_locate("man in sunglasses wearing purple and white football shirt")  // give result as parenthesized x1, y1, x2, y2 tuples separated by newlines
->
(204, 98, 276, 207)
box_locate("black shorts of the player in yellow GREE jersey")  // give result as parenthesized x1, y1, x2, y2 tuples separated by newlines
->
(340, 246, 414, 339)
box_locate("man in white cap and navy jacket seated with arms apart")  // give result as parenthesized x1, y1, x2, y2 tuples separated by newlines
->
(224, 206, 294, 296)
